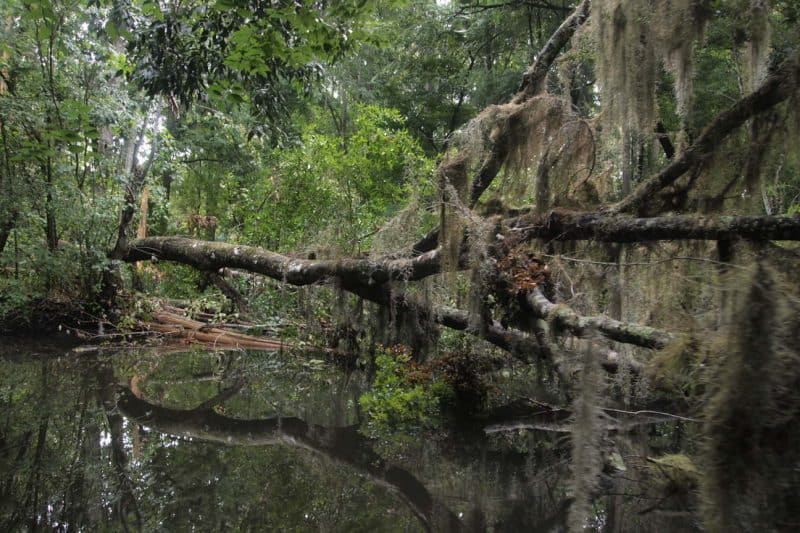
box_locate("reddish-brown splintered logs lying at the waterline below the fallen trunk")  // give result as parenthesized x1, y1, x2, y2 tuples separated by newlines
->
(142, 312, 288, 350)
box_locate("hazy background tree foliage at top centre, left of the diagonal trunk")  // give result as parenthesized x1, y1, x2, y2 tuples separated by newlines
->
(322, 0, 561, 154)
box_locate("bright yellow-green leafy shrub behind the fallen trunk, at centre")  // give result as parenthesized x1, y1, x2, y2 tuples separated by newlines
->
(241, 106, 432, 254)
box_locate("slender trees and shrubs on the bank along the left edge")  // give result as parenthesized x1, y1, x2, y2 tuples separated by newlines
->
(0, 1, 150, 325)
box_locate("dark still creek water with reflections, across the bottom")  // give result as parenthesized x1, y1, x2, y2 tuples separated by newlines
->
(0, 338, 694, 532)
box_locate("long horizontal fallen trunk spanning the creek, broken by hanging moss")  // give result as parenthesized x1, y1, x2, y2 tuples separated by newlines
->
(120, 210, 800, 287)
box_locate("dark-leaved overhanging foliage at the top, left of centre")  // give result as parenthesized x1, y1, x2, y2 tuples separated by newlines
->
(126, 0, 398, 138)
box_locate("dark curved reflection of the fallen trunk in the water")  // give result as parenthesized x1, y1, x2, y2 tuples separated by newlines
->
(117, 389, 461, 531)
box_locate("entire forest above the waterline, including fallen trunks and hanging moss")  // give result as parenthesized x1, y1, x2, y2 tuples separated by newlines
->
(0, 0, 800, 530)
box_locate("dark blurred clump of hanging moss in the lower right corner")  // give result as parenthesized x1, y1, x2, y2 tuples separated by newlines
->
(702, 263, 800, 531)
